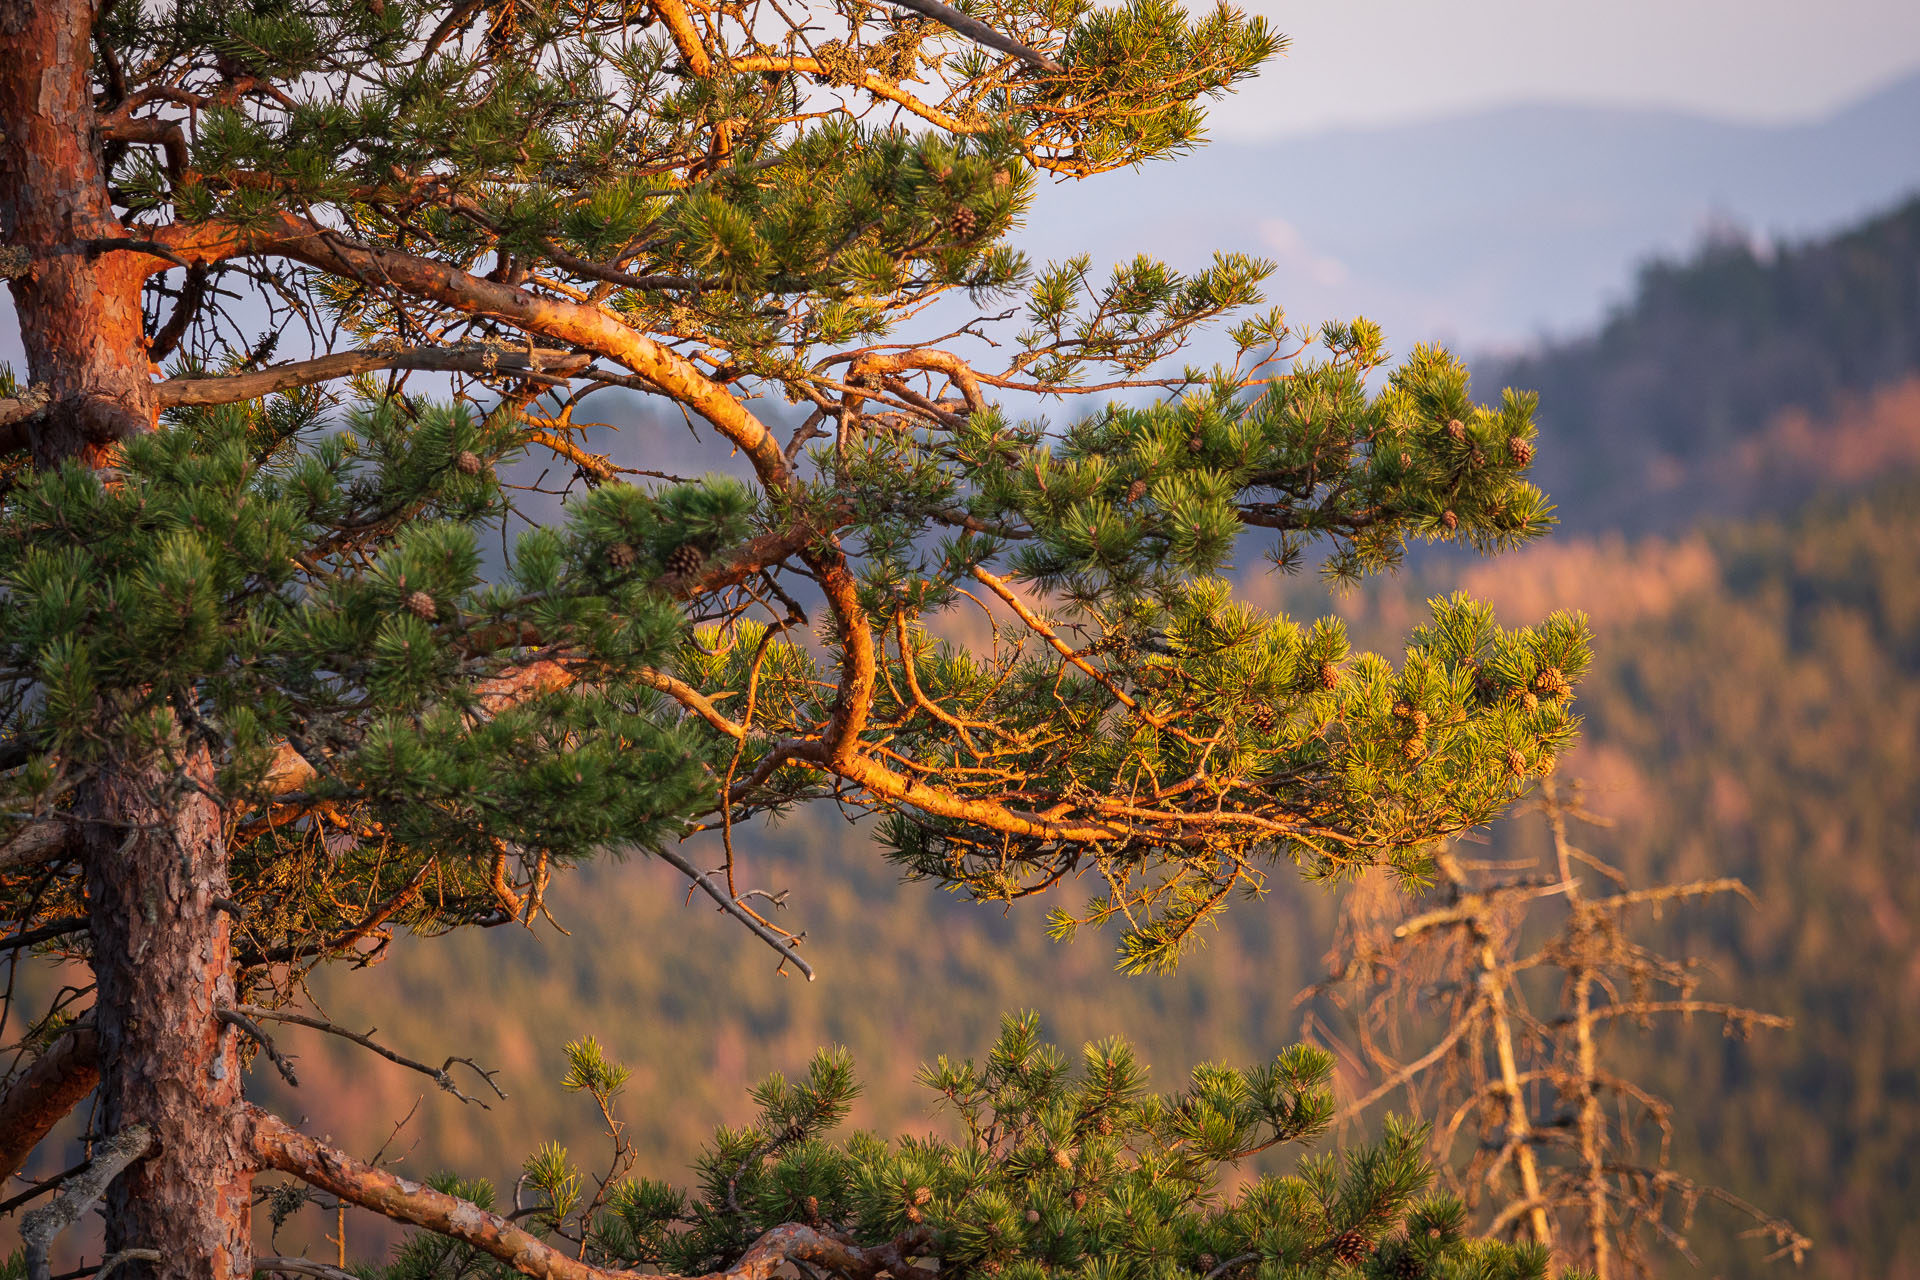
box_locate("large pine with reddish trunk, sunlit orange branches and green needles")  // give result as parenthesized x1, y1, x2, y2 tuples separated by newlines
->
(0, 0, 1586, 1278)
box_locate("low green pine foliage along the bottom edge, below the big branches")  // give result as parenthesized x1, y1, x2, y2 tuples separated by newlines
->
(357, 1013, 1578, 1280)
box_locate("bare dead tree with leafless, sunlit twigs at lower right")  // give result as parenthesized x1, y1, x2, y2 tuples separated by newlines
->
(1300, 777, 1811, 1280)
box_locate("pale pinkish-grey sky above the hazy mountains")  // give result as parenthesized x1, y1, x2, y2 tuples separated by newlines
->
(1188, 0, 1920, 138)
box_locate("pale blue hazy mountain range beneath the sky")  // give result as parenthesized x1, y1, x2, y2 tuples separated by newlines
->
(1023, 75, 1920, 351)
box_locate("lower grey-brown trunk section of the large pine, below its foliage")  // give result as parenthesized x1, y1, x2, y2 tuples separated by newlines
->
(83, 748, 253, 1280)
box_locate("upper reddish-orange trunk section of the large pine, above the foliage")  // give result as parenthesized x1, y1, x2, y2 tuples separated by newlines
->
(0, 0, 156, 466)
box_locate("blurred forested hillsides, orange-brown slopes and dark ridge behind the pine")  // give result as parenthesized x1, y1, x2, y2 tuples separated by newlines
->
(135, 201, 1920, 1278)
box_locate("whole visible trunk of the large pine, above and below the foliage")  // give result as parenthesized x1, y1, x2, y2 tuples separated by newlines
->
(0, 0, 252, 1280)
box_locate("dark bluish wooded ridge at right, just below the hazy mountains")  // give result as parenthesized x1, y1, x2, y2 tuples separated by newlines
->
(1478, 189, 1920, 532)
